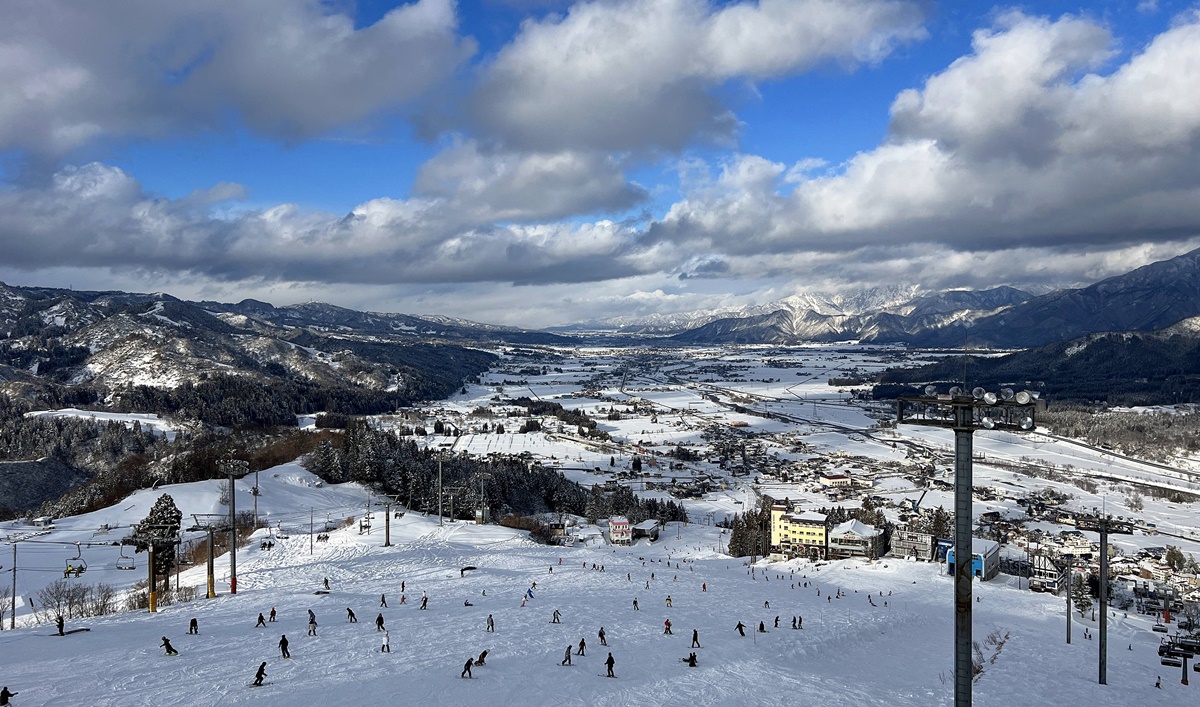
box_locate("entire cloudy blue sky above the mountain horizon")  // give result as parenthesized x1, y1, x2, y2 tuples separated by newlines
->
(0, 0, 1200, 326)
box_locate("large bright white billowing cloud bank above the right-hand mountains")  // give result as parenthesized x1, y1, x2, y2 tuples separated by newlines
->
(647, 14, 1200, 254)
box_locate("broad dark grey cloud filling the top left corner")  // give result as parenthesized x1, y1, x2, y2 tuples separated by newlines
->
(0, 0, 474, 155)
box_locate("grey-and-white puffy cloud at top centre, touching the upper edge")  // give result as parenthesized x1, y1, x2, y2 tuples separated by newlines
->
(472, 0, 925, 151)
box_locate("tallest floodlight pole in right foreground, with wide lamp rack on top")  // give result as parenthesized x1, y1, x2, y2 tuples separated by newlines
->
(896, 385, 1044, 707)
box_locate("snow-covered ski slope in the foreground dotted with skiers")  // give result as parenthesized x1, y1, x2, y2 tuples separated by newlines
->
(0, 465, 1200, 707)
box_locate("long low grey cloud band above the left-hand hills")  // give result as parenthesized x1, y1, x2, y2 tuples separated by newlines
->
(0, 163, 642, 283)
